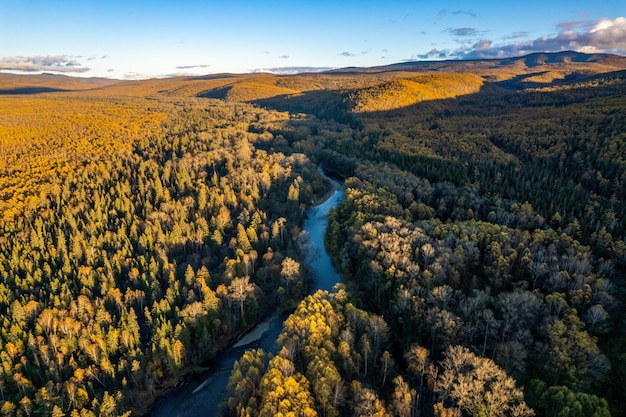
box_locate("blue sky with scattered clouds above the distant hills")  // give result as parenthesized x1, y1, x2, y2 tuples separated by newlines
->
(0, 0, 626, 79)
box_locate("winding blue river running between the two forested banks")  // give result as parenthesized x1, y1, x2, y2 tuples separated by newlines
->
(151, 179, 344, 417)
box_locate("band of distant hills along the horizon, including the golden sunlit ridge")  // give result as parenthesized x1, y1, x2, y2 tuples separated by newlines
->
(0, 51, 626, 103)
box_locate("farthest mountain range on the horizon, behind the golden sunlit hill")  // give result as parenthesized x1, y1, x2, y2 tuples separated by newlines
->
(0, 51, 626, 95)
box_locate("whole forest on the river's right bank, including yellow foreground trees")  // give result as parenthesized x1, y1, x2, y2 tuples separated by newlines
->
(222, 57, 626, 416)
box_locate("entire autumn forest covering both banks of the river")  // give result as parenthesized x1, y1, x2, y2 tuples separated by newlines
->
(0, 52, 626, 417)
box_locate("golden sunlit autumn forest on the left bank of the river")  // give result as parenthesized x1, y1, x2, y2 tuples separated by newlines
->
(0, 92, 332, 416)
